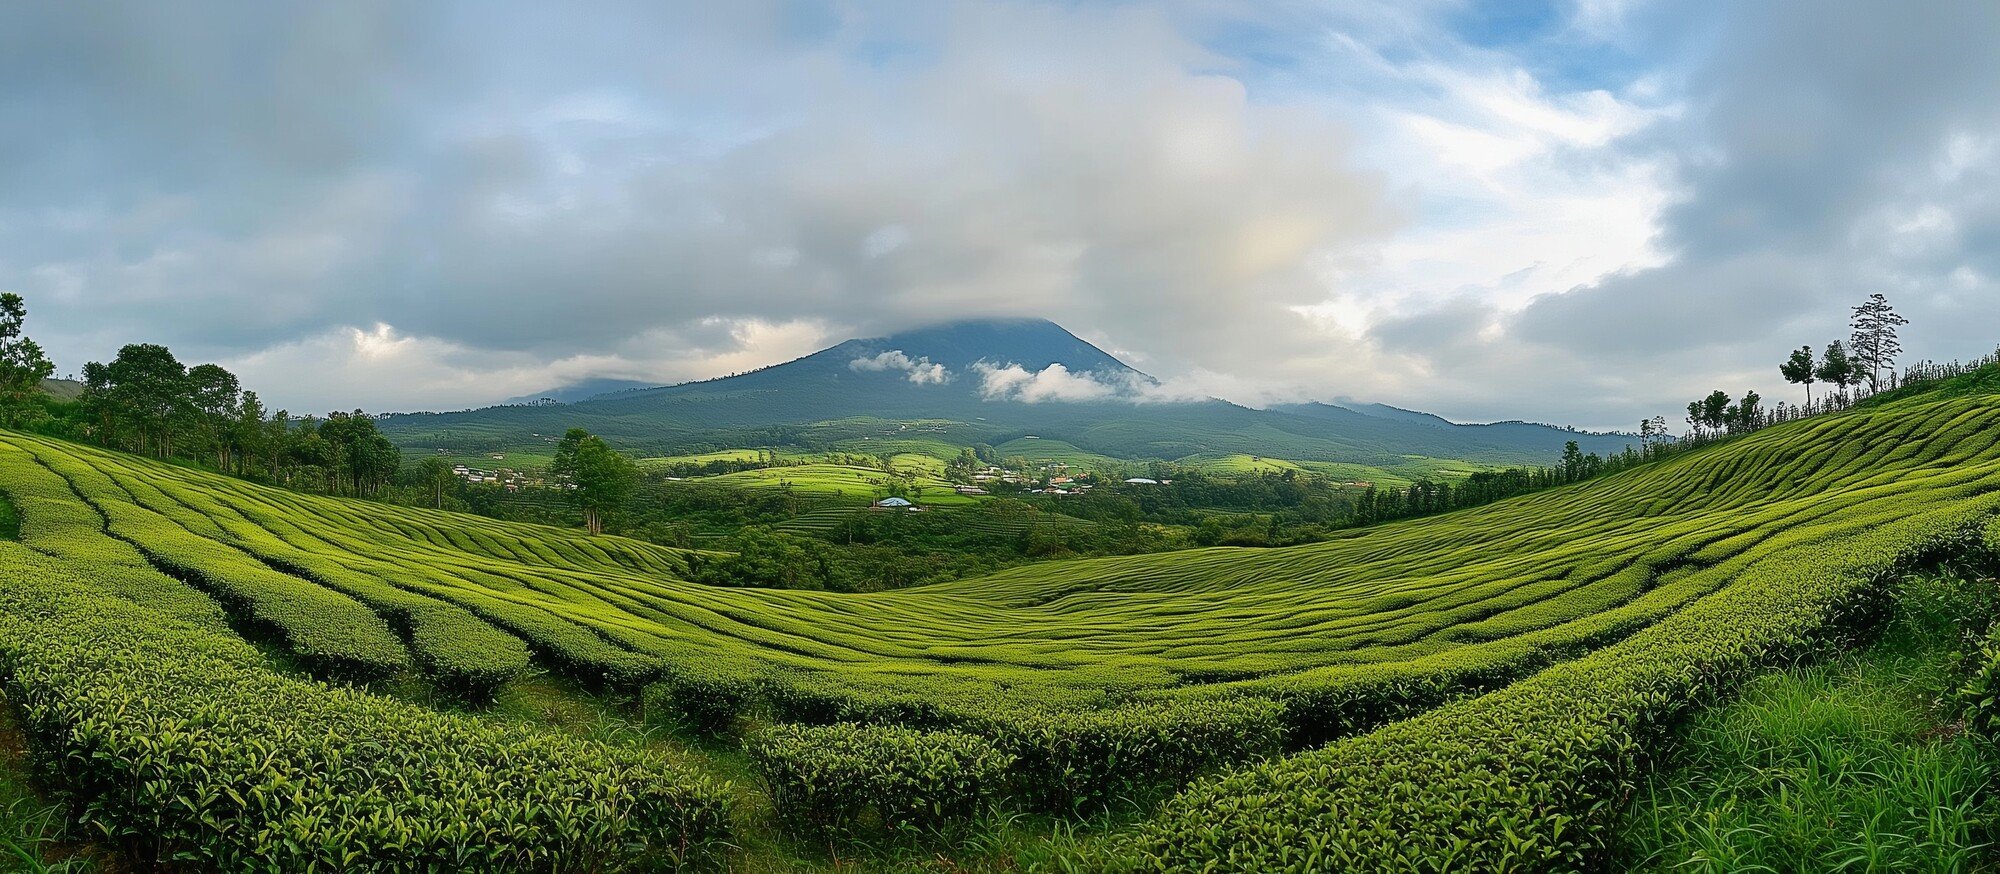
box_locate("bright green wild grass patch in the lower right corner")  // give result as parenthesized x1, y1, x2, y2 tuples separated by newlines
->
(1620, 578, 2000, 872)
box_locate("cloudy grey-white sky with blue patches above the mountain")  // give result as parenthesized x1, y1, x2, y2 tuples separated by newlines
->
(0, 0, 2000, 430)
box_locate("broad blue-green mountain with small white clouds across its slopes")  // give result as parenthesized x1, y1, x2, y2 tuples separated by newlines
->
(382, 320, 1630, 464)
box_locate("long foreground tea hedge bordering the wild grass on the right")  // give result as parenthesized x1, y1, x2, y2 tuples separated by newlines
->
(1084, 498, 2000, 872)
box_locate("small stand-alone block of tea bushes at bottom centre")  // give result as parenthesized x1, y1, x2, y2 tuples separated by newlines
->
(746, 722, 1012, 840)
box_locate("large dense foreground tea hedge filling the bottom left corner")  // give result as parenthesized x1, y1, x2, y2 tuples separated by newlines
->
(0, 544, 728, 872)
